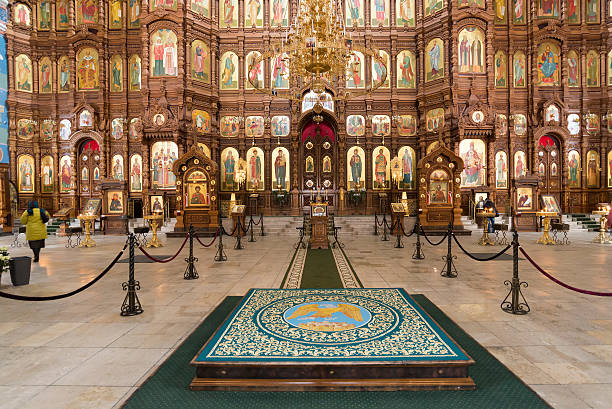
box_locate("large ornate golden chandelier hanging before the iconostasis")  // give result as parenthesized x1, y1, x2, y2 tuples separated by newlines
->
(247, 0, 388, 103)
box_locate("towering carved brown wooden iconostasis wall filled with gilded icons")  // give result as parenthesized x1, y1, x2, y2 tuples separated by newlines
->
(0, 0, 612, 231)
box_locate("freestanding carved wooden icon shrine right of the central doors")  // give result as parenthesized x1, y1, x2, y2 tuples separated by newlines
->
(417, 145, 463, 231)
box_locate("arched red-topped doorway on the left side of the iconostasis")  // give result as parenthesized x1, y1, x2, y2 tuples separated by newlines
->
(75, 138, 102, 208)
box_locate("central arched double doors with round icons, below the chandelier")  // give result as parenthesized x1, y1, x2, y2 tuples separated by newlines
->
(298, 119, 338, 205)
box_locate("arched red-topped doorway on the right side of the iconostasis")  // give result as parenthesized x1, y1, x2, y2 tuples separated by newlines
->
(534, 134, 563, 204)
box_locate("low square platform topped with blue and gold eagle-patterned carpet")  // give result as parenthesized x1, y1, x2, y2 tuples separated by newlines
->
(191, 288, 474, 389)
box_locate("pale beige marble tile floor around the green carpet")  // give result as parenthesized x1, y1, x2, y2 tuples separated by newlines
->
(0, 220, 612, 409)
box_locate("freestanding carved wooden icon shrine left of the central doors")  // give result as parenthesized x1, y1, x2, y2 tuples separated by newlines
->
(172, 145, 219, 234)
